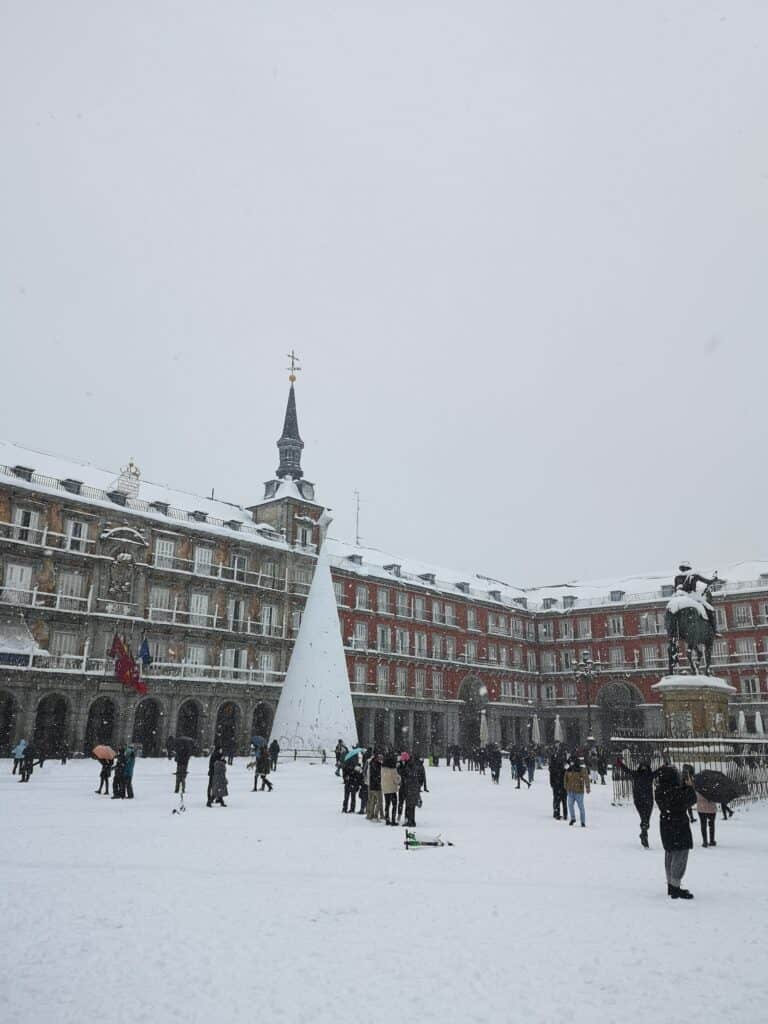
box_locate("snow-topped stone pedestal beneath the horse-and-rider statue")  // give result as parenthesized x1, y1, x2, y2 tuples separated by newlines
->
(651, 676, 736, 736)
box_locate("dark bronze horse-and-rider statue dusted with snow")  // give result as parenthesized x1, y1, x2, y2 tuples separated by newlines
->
(665, 562, 719, 676)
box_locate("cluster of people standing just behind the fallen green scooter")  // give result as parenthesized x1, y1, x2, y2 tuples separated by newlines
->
(335, 740, 429, 828)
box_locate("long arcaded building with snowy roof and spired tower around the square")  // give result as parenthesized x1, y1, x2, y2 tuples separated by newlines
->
(0, 383, 768, 753)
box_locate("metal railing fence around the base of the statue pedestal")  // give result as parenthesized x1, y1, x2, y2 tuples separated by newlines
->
(611, 735, 768, 804)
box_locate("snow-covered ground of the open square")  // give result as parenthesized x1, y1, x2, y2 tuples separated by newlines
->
(0, 760, 768, 1024)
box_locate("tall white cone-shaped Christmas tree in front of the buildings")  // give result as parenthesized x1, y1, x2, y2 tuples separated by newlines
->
(270, 520, 357, 752)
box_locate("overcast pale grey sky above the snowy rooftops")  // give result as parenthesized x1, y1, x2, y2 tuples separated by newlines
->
(0, 0, 768, 585)
